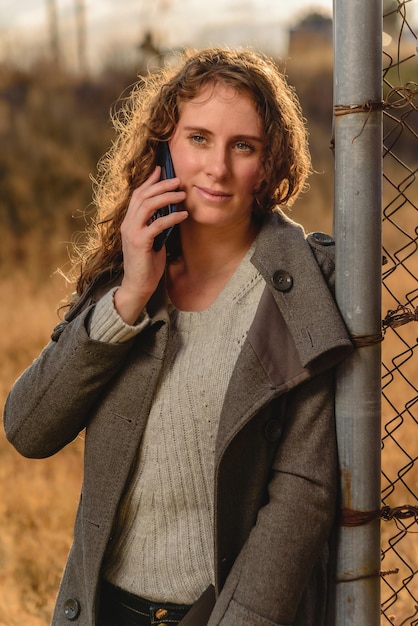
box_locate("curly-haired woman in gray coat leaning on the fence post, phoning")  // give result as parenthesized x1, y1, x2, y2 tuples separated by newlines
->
(5, 49, 351, 626)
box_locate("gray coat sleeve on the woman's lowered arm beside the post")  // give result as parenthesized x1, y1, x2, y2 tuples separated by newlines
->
(209, 372, 337, 626)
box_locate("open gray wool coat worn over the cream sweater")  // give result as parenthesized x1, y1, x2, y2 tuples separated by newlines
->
(4, 213, 352, 626)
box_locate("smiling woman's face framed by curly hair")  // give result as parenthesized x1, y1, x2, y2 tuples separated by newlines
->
(170, 84, 265, 227)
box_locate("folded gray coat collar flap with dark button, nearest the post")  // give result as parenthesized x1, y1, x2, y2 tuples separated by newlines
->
(250, 212, 351, 370)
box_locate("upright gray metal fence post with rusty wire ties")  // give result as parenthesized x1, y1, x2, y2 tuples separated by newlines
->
(332, 0, 383, 626)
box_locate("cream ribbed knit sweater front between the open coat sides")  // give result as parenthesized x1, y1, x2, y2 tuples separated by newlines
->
(104, 249, 264, 604)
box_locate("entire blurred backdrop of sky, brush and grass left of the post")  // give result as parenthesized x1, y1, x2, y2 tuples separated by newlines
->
(0, 0, 418, 626)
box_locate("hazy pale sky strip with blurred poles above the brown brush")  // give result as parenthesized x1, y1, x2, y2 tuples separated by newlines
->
(0, 0, 332, 72)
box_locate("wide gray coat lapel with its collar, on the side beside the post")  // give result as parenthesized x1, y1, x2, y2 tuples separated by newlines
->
(216, 213, 352, 460)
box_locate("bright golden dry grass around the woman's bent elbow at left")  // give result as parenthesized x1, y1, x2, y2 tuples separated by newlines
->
(0, 276, 82, 626)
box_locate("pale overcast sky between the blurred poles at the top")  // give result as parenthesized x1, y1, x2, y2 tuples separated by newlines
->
(0, 0, 332, 65)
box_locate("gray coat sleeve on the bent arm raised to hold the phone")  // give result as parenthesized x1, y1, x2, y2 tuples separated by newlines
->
(4, 307, 132, 458)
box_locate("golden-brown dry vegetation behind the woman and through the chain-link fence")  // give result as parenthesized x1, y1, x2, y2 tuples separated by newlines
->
(0, 42, 418, 626)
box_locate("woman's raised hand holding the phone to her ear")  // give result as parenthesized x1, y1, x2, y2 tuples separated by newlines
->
(115, 167, 188, 324)
